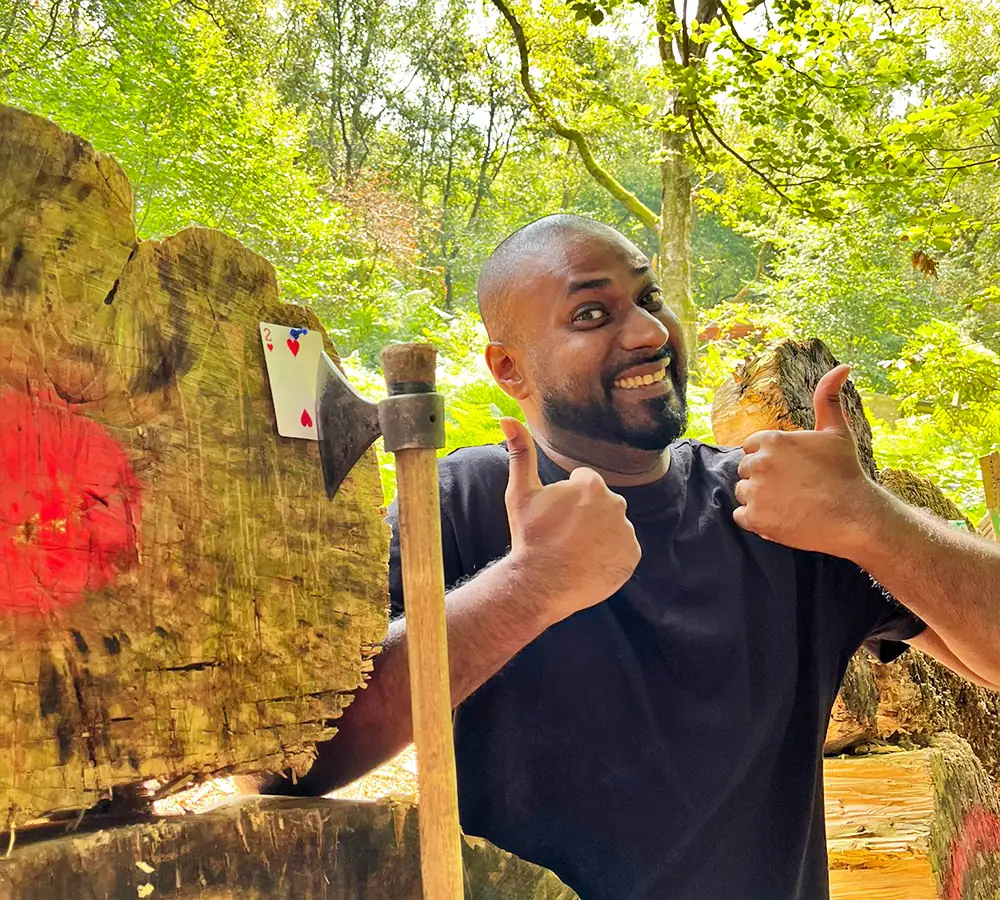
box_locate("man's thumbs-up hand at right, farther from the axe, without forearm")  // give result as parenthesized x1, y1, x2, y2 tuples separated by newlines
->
(733, 366, 878, 557)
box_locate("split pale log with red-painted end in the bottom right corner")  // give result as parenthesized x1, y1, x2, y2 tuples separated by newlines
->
(824, 735, 1000, 900)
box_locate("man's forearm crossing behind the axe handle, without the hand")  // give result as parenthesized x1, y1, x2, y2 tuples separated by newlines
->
(268, 557, 551, 796)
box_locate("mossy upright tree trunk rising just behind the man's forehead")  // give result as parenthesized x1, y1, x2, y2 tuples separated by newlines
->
(657, 131, 698, 356)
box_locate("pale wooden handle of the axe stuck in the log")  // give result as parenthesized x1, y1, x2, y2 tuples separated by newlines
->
(382, 345, 464, 900)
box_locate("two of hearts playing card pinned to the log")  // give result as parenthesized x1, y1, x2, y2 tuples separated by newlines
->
(260, 322, 323, 441)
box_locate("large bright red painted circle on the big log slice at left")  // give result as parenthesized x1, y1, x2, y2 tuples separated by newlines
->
(0, 390, 140, 614)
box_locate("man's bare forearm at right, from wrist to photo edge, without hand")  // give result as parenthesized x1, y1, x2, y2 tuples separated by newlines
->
(841, 488, 1000, 684)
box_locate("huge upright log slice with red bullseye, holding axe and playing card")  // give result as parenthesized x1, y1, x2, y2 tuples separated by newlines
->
(0, 107, 388, 828)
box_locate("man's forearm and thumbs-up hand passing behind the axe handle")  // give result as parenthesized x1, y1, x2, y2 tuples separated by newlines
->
(267, 419, 641, 795)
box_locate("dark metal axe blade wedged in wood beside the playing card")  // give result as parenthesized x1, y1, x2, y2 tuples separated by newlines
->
(316, 353, 382, 500)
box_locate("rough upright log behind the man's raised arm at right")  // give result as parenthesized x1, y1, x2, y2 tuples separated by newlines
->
(712, 341, 1000, 782)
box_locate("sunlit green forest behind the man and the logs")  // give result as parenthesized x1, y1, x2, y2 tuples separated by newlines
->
(0, 0, 1000, 521)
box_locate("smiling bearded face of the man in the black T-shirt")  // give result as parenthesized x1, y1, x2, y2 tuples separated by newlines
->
(515, 234, 687, 450)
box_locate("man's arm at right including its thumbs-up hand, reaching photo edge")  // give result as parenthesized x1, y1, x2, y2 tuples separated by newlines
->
(733, 366, 1000, 686)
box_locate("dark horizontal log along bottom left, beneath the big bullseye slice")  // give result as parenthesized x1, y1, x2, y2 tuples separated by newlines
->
(0, 797, 576, 900)
